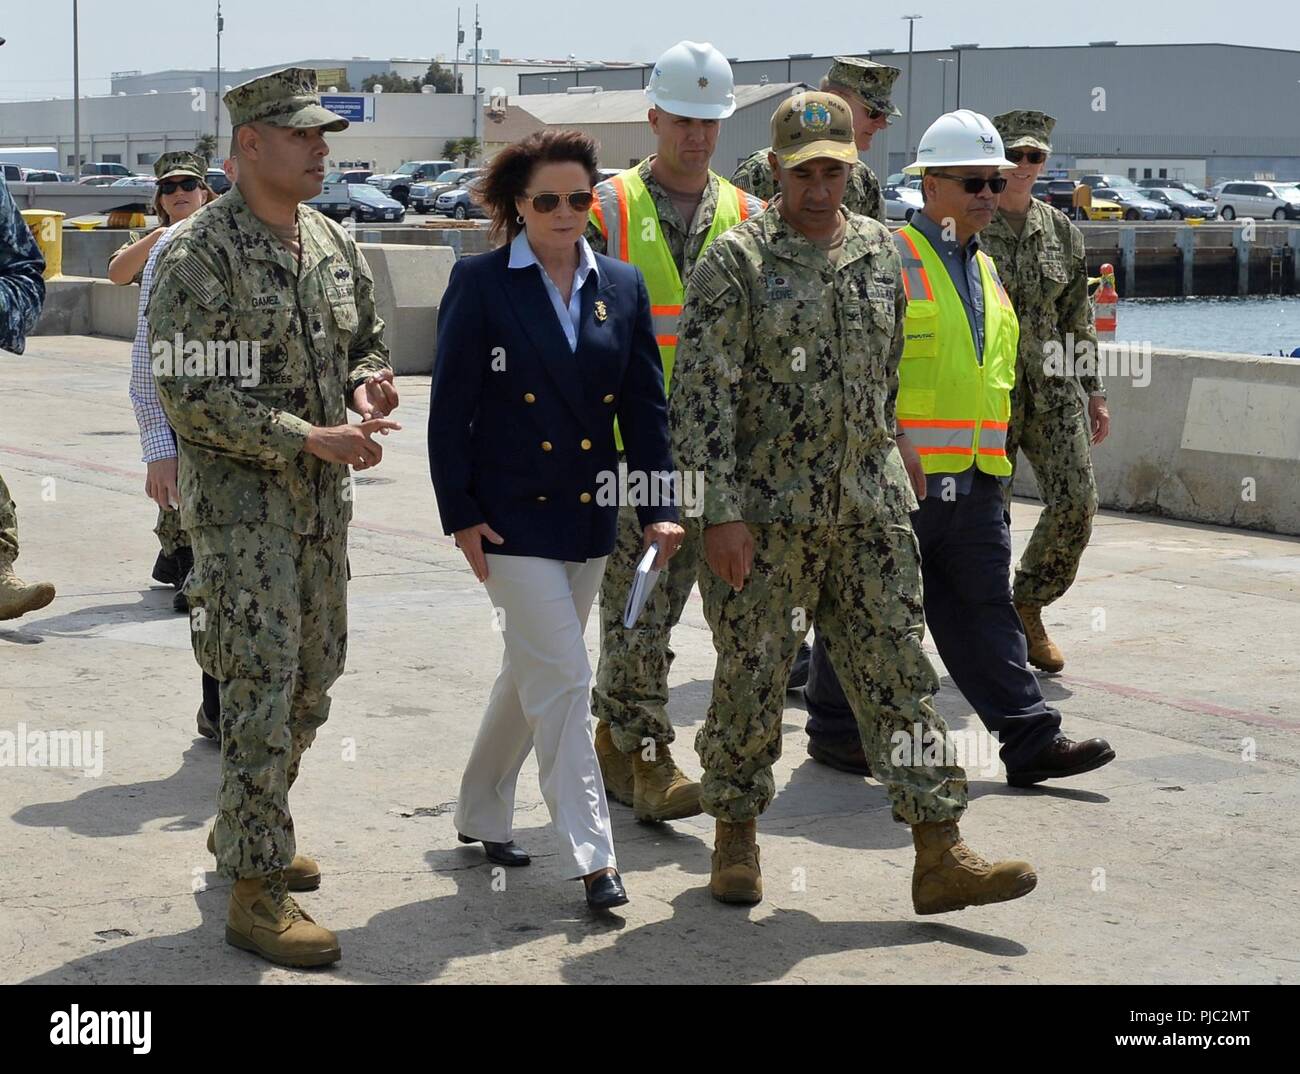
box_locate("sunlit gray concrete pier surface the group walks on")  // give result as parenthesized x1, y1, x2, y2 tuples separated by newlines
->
(0, 337, 1300, 983)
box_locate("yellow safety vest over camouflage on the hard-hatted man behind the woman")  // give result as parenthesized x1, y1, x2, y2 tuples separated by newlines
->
(592, 165, 749, 451)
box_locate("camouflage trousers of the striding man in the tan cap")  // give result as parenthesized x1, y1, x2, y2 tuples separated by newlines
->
(696, 517, 966, 824)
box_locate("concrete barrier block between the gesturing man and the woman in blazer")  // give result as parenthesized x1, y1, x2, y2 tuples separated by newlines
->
(360, 242, 456, 373)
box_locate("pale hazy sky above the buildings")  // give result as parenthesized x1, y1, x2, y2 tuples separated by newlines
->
(0, 0, 1300, 100)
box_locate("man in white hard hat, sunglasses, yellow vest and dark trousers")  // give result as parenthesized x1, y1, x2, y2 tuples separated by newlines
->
(814, 109, 1115, 787)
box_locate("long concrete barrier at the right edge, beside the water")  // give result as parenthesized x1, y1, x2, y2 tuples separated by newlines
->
(1013, 346, 1300, 534)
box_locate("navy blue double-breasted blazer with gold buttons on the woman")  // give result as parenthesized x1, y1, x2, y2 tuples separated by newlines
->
(429, 244, 677, 562)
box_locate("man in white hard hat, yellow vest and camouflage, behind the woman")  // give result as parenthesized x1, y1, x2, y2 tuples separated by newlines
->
(586, 42, 763, 820)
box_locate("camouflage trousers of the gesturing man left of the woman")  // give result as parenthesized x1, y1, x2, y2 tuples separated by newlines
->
(185, 523, 347, 879)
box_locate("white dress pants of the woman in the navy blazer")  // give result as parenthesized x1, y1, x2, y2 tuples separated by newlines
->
(456, 554, 618, 879)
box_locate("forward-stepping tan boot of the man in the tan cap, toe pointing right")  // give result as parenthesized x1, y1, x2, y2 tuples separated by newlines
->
(911, 820, 1039, 914)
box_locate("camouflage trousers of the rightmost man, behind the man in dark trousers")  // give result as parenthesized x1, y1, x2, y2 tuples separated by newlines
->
(1006, 391, 1097, 606)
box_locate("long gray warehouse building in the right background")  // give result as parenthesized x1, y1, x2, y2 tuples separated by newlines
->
(514, 42, 1300, 183)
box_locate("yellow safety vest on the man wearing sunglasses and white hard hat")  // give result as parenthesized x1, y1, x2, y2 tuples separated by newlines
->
(894, 224, 1021, 477)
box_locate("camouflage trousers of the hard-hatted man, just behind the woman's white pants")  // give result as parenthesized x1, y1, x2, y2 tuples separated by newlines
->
(592, 507, 703, 753)
